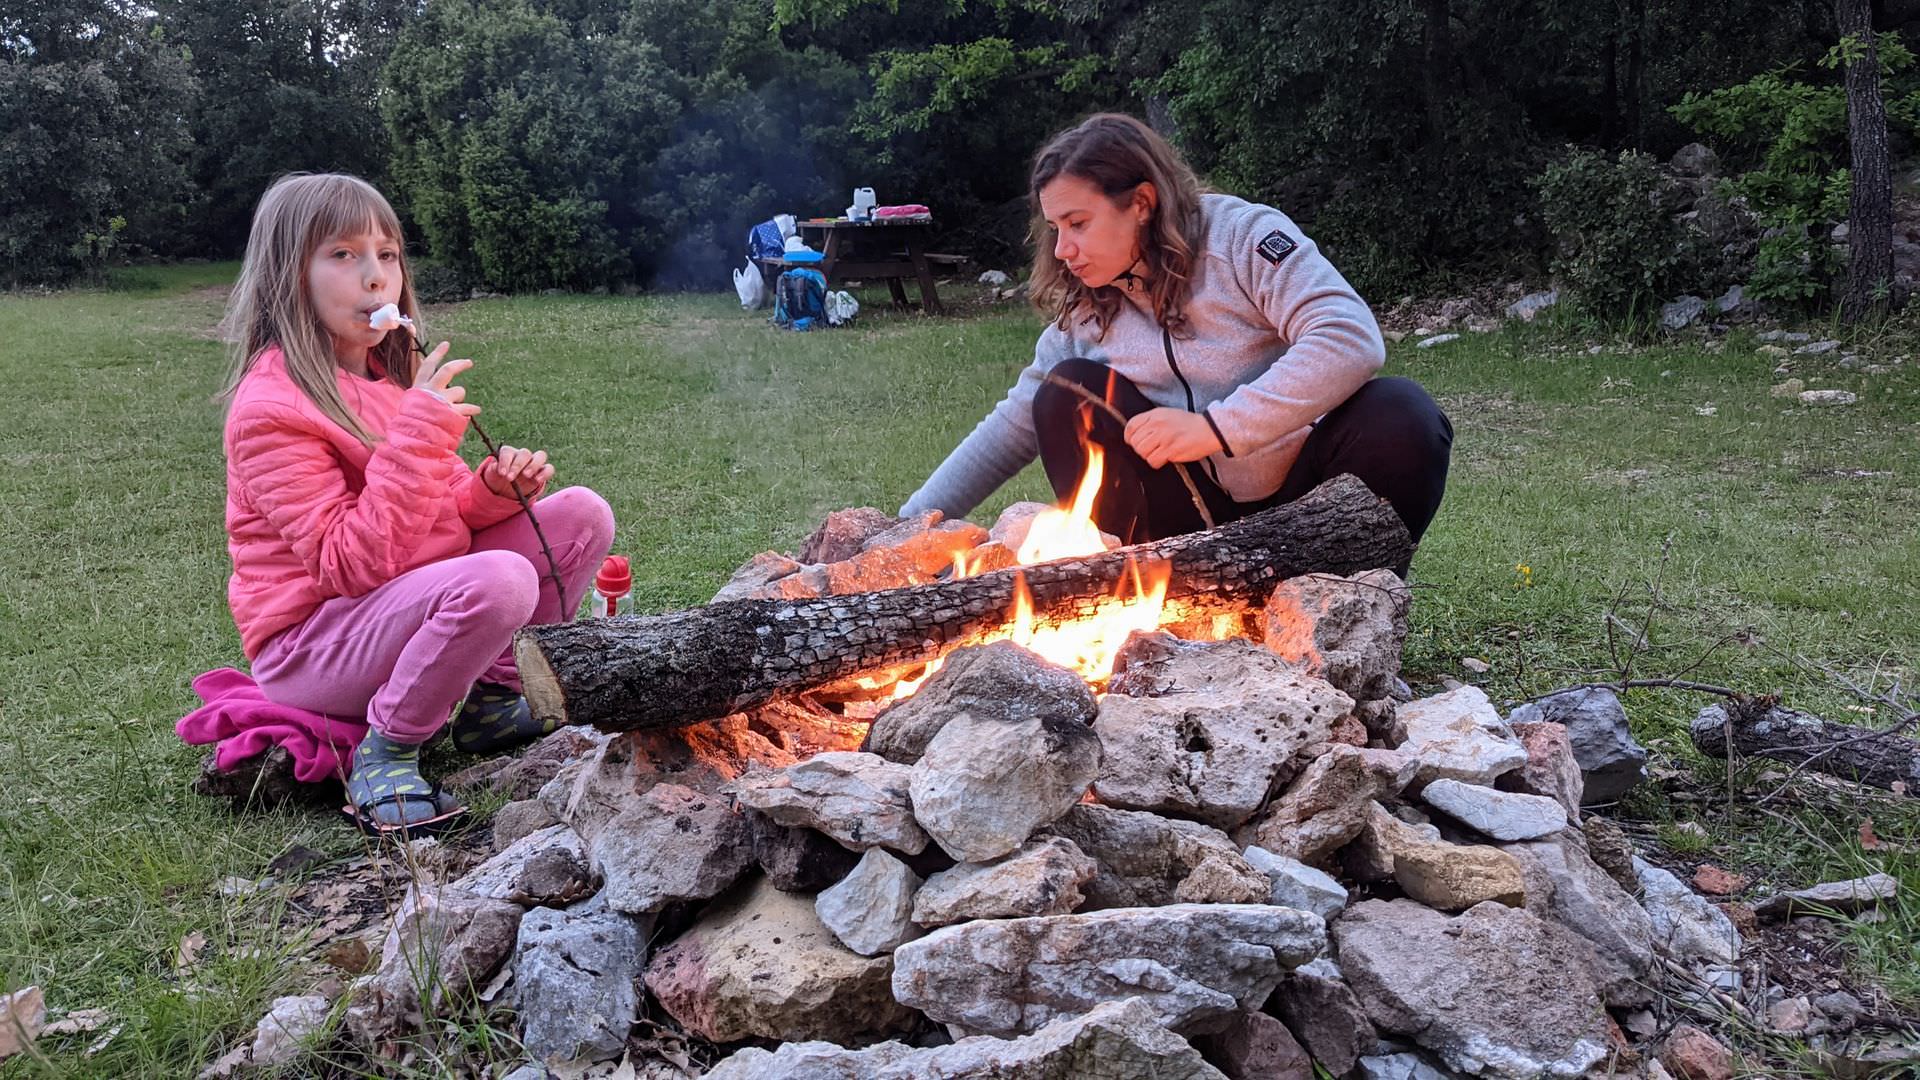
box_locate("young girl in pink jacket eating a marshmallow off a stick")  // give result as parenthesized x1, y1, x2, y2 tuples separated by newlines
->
(225, 175, 612, 832)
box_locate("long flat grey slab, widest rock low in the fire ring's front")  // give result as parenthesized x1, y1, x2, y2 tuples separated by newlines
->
(893, 903, 1327, 1036)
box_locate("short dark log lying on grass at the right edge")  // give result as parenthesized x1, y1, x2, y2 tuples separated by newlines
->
(1690, 698, 1920, 796)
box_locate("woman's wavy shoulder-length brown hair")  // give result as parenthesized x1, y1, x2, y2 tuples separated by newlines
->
(1027, 113, 1206, 336)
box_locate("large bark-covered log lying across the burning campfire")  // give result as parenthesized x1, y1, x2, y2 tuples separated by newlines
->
(513, 475, 1413, 730)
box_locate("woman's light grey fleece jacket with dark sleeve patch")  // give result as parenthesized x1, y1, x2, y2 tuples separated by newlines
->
(900, 194, 1386, 517)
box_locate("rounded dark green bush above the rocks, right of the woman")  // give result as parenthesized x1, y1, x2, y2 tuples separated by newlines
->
(1532, 150, 1695, 317)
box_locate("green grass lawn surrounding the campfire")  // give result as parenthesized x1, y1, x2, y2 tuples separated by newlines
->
(0, 265, 1920, 1076)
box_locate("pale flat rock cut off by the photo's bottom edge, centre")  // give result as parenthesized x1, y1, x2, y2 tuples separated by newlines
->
(707, 997, 1225, 1080)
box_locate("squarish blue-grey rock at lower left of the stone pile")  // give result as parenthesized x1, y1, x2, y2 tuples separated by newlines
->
(513, 905, 651, 1063)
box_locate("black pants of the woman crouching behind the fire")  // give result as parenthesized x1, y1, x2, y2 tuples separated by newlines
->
(1033, 357, 1453, 544)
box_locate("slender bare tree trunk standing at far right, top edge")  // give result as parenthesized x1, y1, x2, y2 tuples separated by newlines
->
(1834, 0, 1893, 323)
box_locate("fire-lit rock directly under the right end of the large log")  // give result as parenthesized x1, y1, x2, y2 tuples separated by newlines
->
(1260, 571, 1413, 701)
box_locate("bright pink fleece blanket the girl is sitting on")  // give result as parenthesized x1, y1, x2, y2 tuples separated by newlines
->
(173, 667, 367, 784)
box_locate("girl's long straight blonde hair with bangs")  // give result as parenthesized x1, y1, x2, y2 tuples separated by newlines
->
(221, 173, 426, 444)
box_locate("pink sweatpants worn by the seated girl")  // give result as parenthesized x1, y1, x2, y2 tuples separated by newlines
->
(253, 488, 612, 744)
